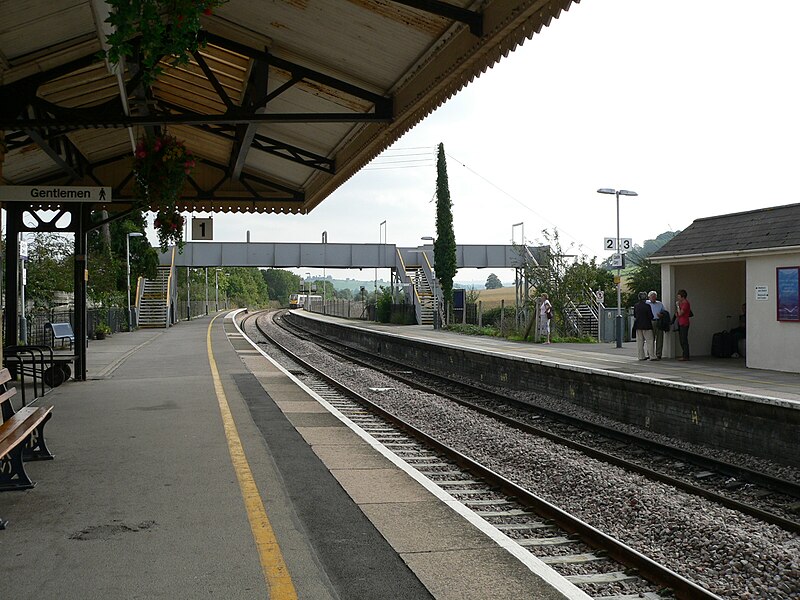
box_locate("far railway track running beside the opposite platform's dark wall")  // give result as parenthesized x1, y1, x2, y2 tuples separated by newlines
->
(276, 308, 800, 533)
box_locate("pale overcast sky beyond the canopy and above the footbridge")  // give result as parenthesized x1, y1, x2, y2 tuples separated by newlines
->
(156, 0, 800, 281)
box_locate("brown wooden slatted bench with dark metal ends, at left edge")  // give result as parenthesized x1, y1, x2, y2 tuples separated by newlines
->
(0, 369, 54, 529)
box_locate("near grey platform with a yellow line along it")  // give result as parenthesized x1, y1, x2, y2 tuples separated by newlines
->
(0, 313, 587, 600)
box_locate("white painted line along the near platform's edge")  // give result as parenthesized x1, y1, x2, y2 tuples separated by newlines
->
(231, 309, 592, 600)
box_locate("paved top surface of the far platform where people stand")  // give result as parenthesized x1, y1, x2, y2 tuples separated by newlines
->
(296, 310, 800, 409)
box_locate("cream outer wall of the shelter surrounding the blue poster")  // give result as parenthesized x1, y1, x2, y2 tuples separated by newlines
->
(747, 252, 800, 373)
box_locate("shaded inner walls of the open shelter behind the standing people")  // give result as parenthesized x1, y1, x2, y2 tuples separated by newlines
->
(661, 260, 749, 358)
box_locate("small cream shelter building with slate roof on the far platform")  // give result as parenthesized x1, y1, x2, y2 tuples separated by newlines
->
(651, 204, 800, 373)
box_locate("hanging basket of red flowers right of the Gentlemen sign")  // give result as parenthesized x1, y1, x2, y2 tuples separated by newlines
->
(133, 135, 195, 251)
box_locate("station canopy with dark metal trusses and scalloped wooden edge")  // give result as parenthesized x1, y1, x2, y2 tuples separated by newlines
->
(0, 0, 578, 213)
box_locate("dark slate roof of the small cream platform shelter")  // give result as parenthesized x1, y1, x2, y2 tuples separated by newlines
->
(651, 204, 800, 260)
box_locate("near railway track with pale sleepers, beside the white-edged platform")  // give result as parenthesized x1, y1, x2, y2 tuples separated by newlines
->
(236, 313, 719, 600)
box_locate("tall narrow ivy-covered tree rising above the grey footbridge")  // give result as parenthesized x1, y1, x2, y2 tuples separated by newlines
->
(433, 144, 458, 304)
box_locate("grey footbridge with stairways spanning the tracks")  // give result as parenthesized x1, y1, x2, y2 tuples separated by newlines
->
(147, 242, 549, 327)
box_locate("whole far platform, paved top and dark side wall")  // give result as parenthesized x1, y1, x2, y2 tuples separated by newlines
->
(291, 310, 800, 466)
